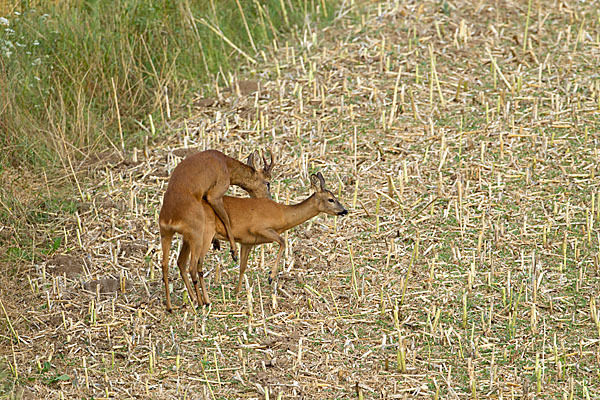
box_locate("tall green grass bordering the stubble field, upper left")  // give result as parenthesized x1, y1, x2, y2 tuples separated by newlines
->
(0, 0, 335, 167)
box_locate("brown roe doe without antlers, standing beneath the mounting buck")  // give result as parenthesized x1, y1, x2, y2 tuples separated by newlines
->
(168, 172, 348, 305)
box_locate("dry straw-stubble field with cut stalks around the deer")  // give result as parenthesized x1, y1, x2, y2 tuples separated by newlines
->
(0, 0, 600, 399)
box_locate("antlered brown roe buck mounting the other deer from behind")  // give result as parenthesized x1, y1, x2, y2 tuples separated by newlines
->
(159, 150, 274, 311)
